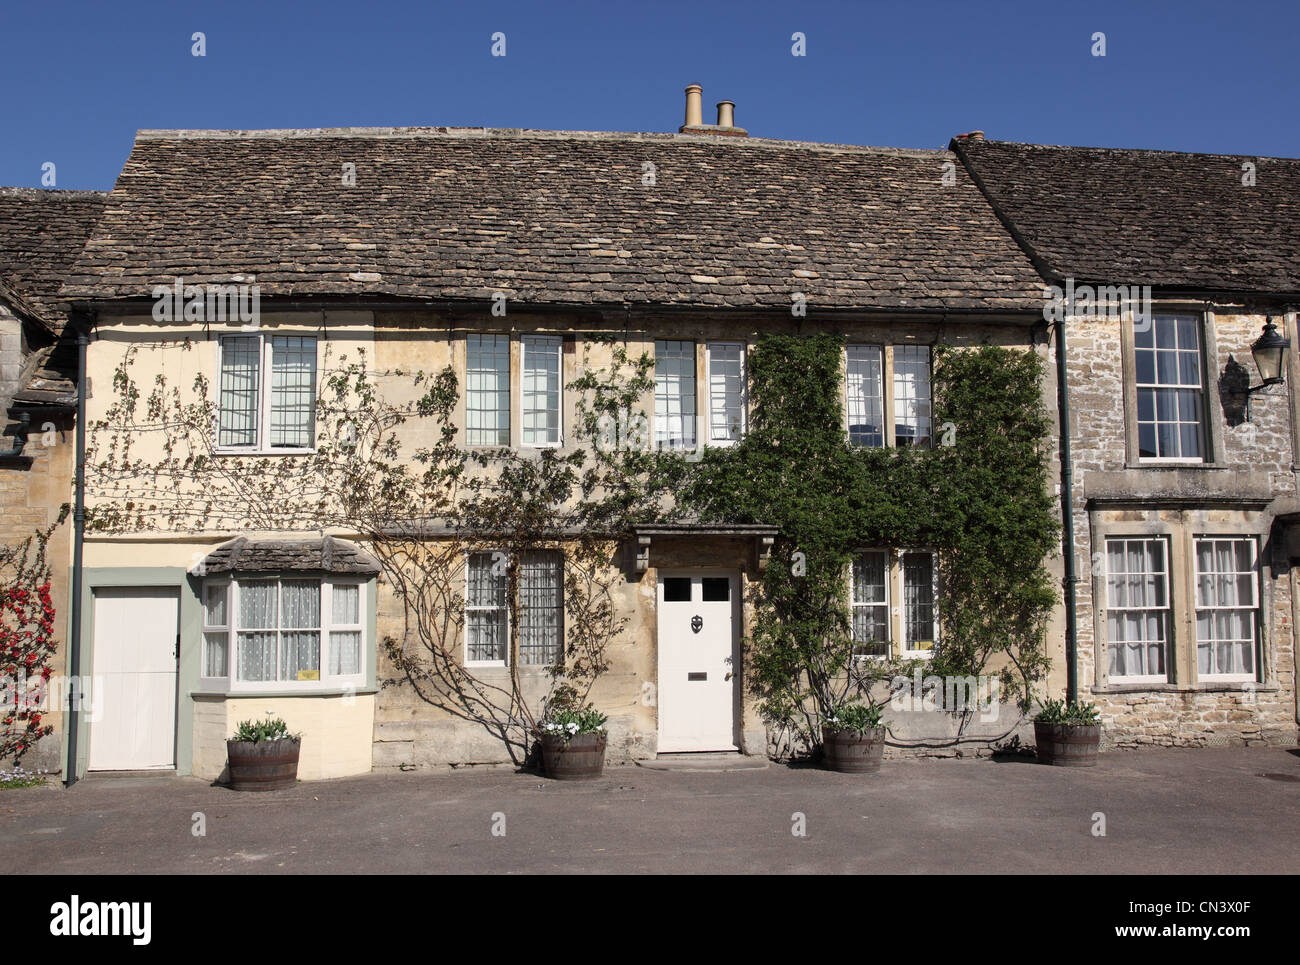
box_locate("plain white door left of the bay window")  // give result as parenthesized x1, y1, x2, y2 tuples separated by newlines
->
(90, 587, 179, 771)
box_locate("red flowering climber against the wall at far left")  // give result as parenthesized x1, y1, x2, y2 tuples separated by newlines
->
(0, 520, 61, 765)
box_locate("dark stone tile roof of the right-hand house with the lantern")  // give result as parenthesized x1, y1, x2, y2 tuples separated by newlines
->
(952, 138, 1300, 293)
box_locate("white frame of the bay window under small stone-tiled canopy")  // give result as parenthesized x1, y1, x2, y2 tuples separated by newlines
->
(199, 572, 371, 693)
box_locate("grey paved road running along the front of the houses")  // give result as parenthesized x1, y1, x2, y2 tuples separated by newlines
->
(0, 748, 1300, 874)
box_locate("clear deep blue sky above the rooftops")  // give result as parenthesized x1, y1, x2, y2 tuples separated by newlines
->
(0, 0, 1300, 189)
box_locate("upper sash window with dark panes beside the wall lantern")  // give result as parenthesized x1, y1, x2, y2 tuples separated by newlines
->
(1134, 315, 1205, 459)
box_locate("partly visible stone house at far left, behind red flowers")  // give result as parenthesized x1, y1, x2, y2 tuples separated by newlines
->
(0, 187, 105, 771)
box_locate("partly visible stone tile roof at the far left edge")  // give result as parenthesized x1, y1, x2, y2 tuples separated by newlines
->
(0, 187, 108, 332)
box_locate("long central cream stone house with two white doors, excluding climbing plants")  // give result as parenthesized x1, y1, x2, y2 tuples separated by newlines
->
(53, 117, 1063, 779)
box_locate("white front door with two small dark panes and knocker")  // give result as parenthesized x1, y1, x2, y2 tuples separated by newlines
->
(658, 571, 740, 753)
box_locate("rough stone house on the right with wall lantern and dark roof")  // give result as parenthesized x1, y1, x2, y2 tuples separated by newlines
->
(952, 133, 1300, 747)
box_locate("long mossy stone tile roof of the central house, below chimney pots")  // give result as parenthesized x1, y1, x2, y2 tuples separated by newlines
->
(64, 127, 1041, 311)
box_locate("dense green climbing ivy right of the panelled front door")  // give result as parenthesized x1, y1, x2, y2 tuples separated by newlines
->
(677, 334, 1058, 747)
